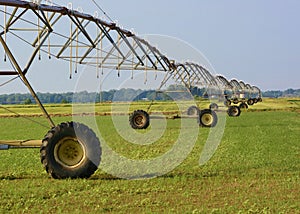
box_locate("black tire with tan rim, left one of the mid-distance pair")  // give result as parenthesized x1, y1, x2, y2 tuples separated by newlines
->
(129, 110, 150, 129)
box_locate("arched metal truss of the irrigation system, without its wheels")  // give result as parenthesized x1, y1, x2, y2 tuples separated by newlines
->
(0, 0, 261, 130)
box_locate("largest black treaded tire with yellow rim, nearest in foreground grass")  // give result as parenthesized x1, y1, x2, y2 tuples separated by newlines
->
(40, 122, 101, 179)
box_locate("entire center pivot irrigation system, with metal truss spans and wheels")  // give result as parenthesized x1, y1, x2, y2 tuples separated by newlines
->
(0, 0, 261, 178)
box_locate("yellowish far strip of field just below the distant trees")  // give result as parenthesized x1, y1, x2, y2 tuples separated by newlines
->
(0, 98, 300, 117)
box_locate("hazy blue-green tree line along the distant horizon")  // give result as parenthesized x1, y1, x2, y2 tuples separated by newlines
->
(0, 85, 300, 104)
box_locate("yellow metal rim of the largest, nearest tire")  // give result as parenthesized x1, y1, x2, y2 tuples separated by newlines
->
(54, 137, 85, 168)
